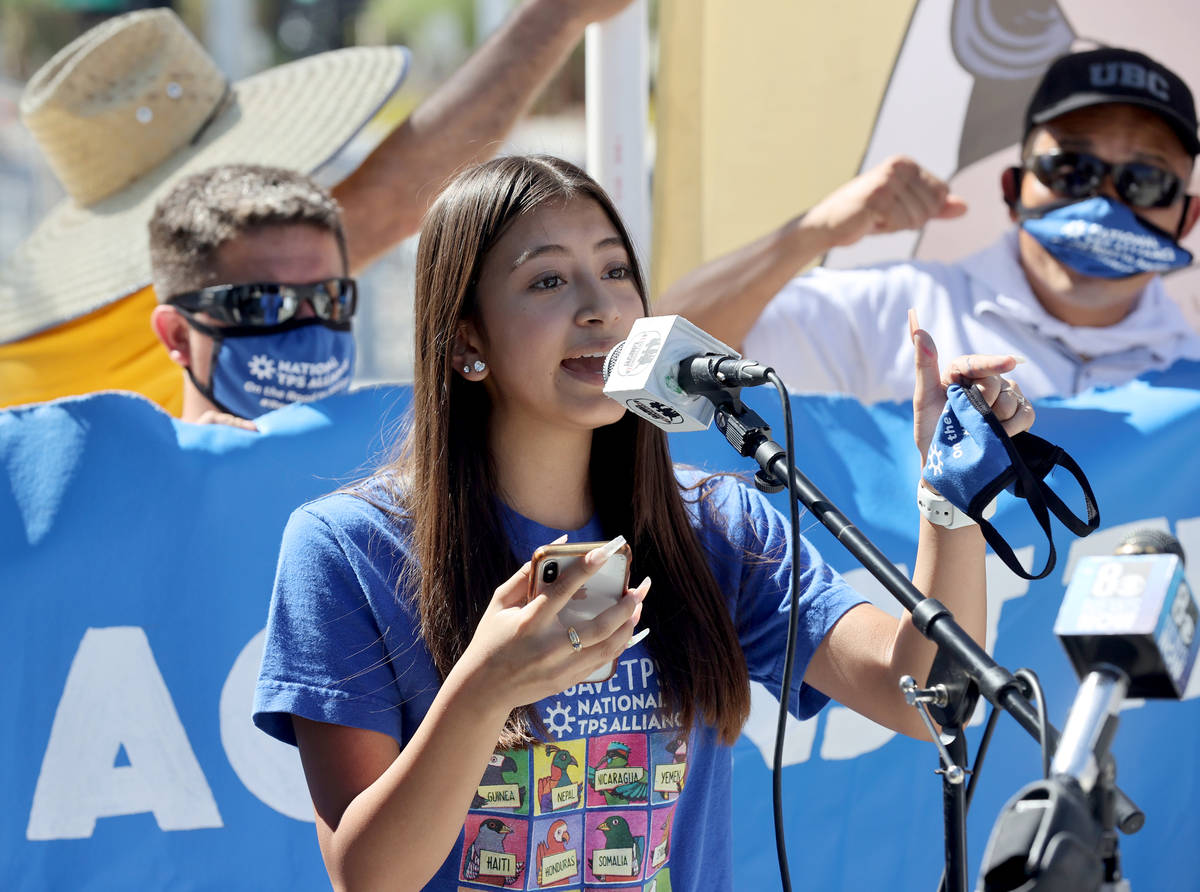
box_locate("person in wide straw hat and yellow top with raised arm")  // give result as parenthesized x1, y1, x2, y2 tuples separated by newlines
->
(0, 0, 630, 414)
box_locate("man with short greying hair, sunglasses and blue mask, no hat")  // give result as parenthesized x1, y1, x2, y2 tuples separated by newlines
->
(150, 164, 358, 430)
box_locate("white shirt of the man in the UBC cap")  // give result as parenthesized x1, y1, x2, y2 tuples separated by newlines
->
(743, 229, 1200, 403)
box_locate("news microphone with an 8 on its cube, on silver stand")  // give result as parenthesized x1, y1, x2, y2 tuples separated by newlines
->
(977, 529, 1200, 892)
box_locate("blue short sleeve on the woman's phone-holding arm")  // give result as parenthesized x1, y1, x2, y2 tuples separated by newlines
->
(253, 497, 402, 744)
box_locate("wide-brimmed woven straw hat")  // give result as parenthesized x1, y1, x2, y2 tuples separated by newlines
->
(0, 8, 408, 343)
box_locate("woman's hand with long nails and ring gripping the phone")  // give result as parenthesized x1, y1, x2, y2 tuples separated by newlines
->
(460, 537, 650, 707)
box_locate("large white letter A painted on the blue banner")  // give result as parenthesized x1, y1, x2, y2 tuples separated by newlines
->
(25, 627, 223, 839)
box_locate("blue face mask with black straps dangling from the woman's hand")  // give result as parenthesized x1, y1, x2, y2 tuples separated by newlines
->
(923, 384, 1100, 579)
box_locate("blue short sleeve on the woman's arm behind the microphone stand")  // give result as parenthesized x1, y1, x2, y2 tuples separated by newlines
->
(705, 484, 864, 719)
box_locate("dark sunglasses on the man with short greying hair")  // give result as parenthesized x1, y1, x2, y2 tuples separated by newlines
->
(167, 279, 359, 325)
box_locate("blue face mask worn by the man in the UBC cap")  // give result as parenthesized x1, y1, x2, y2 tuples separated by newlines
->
(1018, 196, 1192, 279)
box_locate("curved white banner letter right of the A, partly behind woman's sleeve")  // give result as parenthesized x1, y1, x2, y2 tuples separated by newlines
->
(220, 629, 314, 824)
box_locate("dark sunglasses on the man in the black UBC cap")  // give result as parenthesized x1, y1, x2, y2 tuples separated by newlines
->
(1021, 151, 1183, 208)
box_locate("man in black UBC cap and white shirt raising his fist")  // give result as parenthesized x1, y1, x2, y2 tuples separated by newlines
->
(655, 48, 1200, 402)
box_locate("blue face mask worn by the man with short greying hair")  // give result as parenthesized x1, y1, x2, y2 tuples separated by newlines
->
(185, 313, 354, 418)
